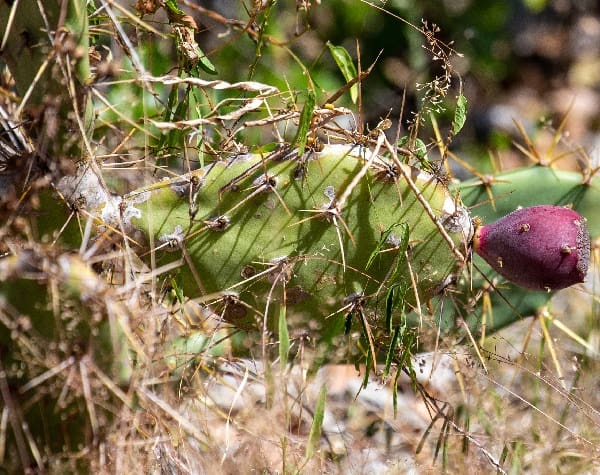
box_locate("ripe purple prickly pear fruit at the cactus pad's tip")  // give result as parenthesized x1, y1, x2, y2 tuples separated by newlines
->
(473, 205, 590, 291)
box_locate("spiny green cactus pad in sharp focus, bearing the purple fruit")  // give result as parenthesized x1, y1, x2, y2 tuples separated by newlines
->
(125, 146, 472, 337)
